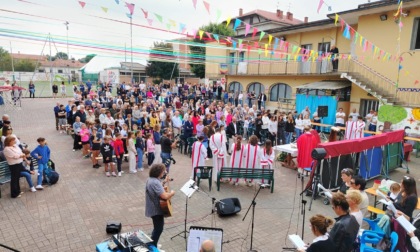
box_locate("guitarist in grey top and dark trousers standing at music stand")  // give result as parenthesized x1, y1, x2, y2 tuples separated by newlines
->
(146, 164, 175, 247)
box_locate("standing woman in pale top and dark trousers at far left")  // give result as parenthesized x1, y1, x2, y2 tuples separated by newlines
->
(3, 136, 25, 198)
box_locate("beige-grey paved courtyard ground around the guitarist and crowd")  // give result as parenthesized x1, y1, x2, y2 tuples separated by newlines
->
(0, 98, 420, 251)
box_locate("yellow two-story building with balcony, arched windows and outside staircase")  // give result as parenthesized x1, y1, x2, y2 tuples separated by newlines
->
(206, 0, 420, 130)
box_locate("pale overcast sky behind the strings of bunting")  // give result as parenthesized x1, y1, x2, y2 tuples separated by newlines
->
(0, 0, 374, 61)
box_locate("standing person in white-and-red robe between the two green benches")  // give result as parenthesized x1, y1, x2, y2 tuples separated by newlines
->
(210, 132, 227, 181)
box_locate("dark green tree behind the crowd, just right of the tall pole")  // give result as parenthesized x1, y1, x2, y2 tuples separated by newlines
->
(146, 42, 179, 80)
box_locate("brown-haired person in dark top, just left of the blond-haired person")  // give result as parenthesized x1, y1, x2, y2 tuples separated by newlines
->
(330, 192, 360, 252)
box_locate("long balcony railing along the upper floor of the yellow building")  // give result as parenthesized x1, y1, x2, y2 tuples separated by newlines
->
(225, 59, 349, 75)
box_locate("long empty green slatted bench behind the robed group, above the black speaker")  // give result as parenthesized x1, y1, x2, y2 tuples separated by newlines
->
(217, 167, 274, 193)
